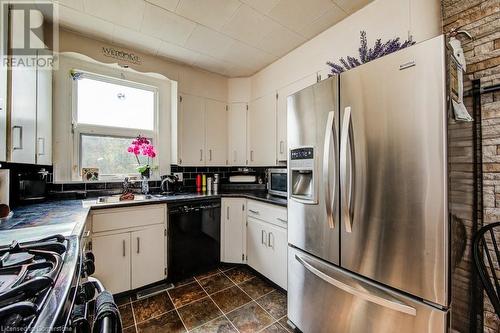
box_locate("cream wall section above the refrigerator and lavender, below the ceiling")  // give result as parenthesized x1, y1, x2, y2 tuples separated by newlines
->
(248, 0, 441, 99)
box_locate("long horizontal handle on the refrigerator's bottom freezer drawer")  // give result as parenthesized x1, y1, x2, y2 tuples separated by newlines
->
(295, 254, 417, 316)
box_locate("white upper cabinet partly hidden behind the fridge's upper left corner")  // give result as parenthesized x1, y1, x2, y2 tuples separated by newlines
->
(276, 73, 317, 161)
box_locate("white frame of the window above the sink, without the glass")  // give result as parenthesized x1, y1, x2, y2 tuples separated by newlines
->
(71, 70, 160, 181)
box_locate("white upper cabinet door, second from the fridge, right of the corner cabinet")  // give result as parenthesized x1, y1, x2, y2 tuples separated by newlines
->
(247, 93, 276, 166)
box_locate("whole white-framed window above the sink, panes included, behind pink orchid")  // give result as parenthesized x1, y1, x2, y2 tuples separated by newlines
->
(72, 71, 158, 180)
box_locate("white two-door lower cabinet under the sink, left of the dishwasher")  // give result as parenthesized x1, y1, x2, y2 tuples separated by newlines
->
(91, 205, 167, 294)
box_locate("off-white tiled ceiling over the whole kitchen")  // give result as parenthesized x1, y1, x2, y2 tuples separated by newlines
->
(53, 0, 372, 77)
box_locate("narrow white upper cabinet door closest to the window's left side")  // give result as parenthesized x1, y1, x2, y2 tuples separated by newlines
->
(36, 65, 52, 165)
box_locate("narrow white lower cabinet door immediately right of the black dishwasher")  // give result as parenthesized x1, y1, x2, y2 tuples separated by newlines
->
(221, 198, 247, 264)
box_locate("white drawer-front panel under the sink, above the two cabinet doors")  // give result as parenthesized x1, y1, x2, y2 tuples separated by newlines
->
(92, 205, 167, 233)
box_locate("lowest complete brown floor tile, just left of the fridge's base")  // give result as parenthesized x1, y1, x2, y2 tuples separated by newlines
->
(227, 302, 273, 333)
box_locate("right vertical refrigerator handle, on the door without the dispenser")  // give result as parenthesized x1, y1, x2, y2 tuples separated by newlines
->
(340, 106, 354, 232)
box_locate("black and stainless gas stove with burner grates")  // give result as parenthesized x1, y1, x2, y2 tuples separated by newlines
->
(0, 235, 102, 332)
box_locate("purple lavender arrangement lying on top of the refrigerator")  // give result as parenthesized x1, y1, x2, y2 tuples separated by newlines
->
(326, 31, 415, 76)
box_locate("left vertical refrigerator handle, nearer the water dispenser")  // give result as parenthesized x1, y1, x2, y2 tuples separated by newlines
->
(323, 111, 337, 229)
